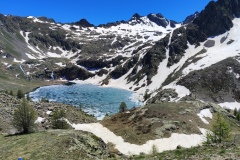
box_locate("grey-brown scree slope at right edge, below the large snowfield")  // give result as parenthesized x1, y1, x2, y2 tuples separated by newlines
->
(178, 58, 240, 103)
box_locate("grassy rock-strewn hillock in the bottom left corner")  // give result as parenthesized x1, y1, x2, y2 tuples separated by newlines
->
(0, 130, 108, 160)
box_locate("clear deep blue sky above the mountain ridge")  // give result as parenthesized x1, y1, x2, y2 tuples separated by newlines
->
(0, 0, 210, 25)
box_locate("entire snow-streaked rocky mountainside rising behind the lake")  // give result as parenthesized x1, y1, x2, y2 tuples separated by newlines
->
(0, 0, 240, 107)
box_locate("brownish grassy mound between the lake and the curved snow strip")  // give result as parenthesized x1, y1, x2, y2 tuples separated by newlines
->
(101, 102, 209, 144)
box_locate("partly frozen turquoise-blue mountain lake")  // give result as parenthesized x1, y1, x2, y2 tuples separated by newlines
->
(29, 84, 142, 120)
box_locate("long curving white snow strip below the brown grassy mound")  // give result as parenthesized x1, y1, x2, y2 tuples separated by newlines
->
(66, 120, 207, 155)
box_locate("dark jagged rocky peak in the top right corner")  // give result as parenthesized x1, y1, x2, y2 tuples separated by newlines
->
(193, 0, 240, 37)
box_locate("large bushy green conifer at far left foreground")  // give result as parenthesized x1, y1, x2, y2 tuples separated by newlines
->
(13, 98, 37, 133)
